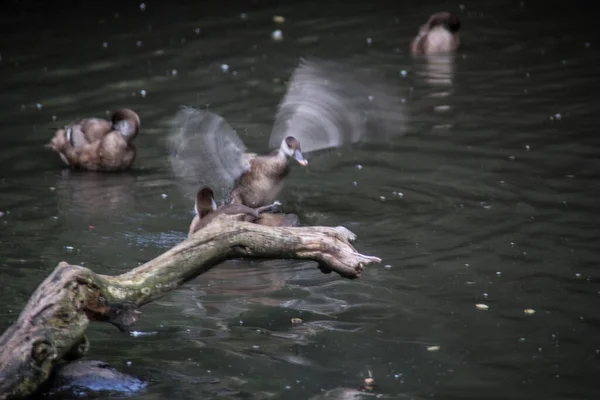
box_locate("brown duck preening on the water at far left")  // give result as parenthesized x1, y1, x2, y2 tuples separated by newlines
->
(46, 108, 140, 172)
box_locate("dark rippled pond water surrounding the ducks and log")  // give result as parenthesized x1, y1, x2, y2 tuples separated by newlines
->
(0, 1, 600, 400)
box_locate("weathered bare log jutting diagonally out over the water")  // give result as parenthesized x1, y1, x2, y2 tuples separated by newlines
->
(0, 216, 381, 399)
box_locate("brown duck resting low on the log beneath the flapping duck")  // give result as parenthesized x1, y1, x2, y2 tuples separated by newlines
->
(188, 186, 298, 237)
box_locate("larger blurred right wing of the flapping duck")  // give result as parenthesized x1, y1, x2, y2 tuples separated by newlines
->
(269, 60, 404, 153)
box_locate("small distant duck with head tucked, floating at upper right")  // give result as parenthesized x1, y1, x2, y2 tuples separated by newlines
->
(410, 12, 460, 55)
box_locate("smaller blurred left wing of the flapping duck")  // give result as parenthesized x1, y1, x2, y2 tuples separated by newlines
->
(169, 107, 248, 203)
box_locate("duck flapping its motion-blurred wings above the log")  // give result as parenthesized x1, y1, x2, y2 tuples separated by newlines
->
(170, 60, 403, 212)
